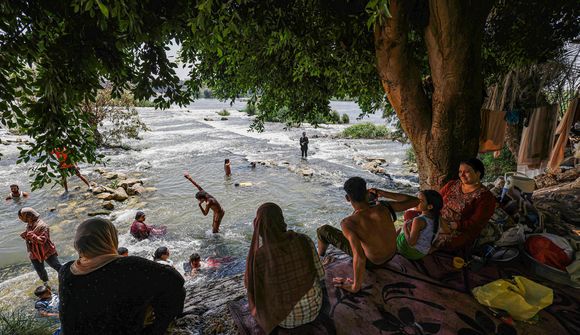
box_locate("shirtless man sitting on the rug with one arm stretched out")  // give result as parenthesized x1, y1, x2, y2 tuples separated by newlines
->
(317, 177, 419, 292)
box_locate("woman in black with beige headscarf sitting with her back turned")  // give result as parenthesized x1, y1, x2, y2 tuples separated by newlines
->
(59, 218, 185, 335)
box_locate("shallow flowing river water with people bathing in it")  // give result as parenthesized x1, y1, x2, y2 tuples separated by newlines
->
(0, 99, 417, 308)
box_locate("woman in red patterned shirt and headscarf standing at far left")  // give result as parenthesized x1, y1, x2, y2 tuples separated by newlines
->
(18, 207, 61, 285)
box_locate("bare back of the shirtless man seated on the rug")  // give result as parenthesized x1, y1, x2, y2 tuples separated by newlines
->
(341, 205, 397, 265)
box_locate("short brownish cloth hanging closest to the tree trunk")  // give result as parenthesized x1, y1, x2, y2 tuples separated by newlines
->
(479, 109, 506, 153)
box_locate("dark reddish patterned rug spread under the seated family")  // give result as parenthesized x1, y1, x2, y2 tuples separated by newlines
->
(230, 254, 580, 335)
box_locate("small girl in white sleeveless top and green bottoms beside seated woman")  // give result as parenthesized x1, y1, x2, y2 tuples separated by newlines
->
(397, 190, 443, 260)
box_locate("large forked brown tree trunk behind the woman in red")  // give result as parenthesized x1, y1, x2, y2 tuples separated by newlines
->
(375, 0, 491, 189)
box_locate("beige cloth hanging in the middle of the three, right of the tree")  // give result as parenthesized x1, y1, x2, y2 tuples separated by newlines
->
(518, 105, 558, 171)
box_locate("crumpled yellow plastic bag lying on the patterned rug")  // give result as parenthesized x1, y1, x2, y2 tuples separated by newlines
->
(472, 276, 554, 320)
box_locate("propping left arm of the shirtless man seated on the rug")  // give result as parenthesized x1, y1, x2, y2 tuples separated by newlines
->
(333, 219, 367, 293)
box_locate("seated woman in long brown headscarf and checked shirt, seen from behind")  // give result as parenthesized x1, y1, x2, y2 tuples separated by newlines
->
(245, 202, 324, 334)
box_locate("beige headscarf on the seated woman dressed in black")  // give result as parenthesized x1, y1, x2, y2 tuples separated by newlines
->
(70, 218, 121, 275)
